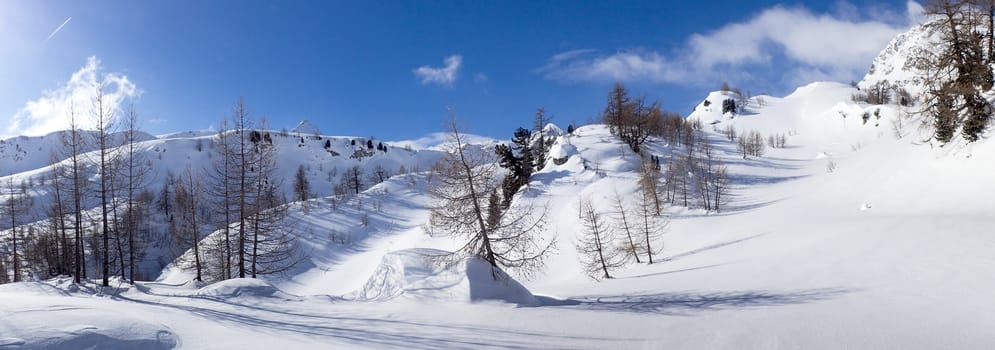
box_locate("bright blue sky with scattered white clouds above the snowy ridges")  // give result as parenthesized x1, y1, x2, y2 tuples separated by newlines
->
(0, 0, 920, 140)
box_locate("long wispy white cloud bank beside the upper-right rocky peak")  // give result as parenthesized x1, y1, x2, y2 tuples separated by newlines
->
(539, 1, 922, 84)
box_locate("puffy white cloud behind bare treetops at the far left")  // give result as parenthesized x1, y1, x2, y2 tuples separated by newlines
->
(6, 56, 141, 135)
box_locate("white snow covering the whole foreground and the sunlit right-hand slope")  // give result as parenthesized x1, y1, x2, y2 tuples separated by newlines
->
(0, 23, 995, 349)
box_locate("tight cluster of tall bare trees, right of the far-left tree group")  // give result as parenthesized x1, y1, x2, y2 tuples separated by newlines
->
(197, 98, 299, 280)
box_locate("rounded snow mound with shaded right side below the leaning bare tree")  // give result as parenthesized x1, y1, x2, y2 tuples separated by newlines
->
(354, 249, 539, 305)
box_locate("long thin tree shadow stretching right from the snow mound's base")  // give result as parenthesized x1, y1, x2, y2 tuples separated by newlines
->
(540, 288, 852, 316)
